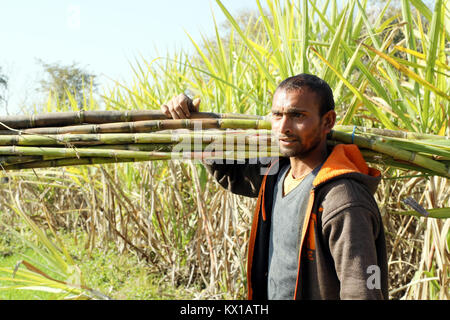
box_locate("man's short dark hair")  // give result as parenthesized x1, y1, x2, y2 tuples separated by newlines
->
(276, 73, 334, 116)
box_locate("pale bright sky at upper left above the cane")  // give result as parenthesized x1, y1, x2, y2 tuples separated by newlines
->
(0, 0, 256, 115)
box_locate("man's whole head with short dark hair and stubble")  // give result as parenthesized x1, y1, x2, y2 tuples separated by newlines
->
(272, 74, 336, 159)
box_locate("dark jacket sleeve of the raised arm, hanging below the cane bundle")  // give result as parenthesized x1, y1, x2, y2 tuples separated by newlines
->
(203, 158, 270, 198)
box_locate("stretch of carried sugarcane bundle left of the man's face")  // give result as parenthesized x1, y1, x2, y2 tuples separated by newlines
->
(0, 110, 272, 170)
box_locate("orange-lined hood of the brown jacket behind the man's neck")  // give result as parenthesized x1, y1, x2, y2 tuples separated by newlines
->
(313, 144, 381, 194)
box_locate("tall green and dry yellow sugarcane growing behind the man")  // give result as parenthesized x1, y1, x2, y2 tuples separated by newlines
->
(0, 0, 450, 299)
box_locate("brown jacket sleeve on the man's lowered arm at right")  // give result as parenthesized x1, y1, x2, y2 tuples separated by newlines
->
(322, 205, 387, 300)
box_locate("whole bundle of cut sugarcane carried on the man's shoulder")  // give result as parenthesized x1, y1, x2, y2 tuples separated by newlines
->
(0, 110, 450, 178)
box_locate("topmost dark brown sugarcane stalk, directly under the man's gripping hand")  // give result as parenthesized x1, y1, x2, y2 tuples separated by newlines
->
(0, 110, 263, 129)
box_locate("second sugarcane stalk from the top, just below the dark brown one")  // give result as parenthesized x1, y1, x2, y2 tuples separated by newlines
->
(7, 119, 271, 135)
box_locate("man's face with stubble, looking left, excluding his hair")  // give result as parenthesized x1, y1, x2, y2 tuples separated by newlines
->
(272, 87, 326, 159)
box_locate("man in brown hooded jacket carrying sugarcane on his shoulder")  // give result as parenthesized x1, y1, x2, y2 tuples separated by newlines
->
(161, 74, 388, 300)
